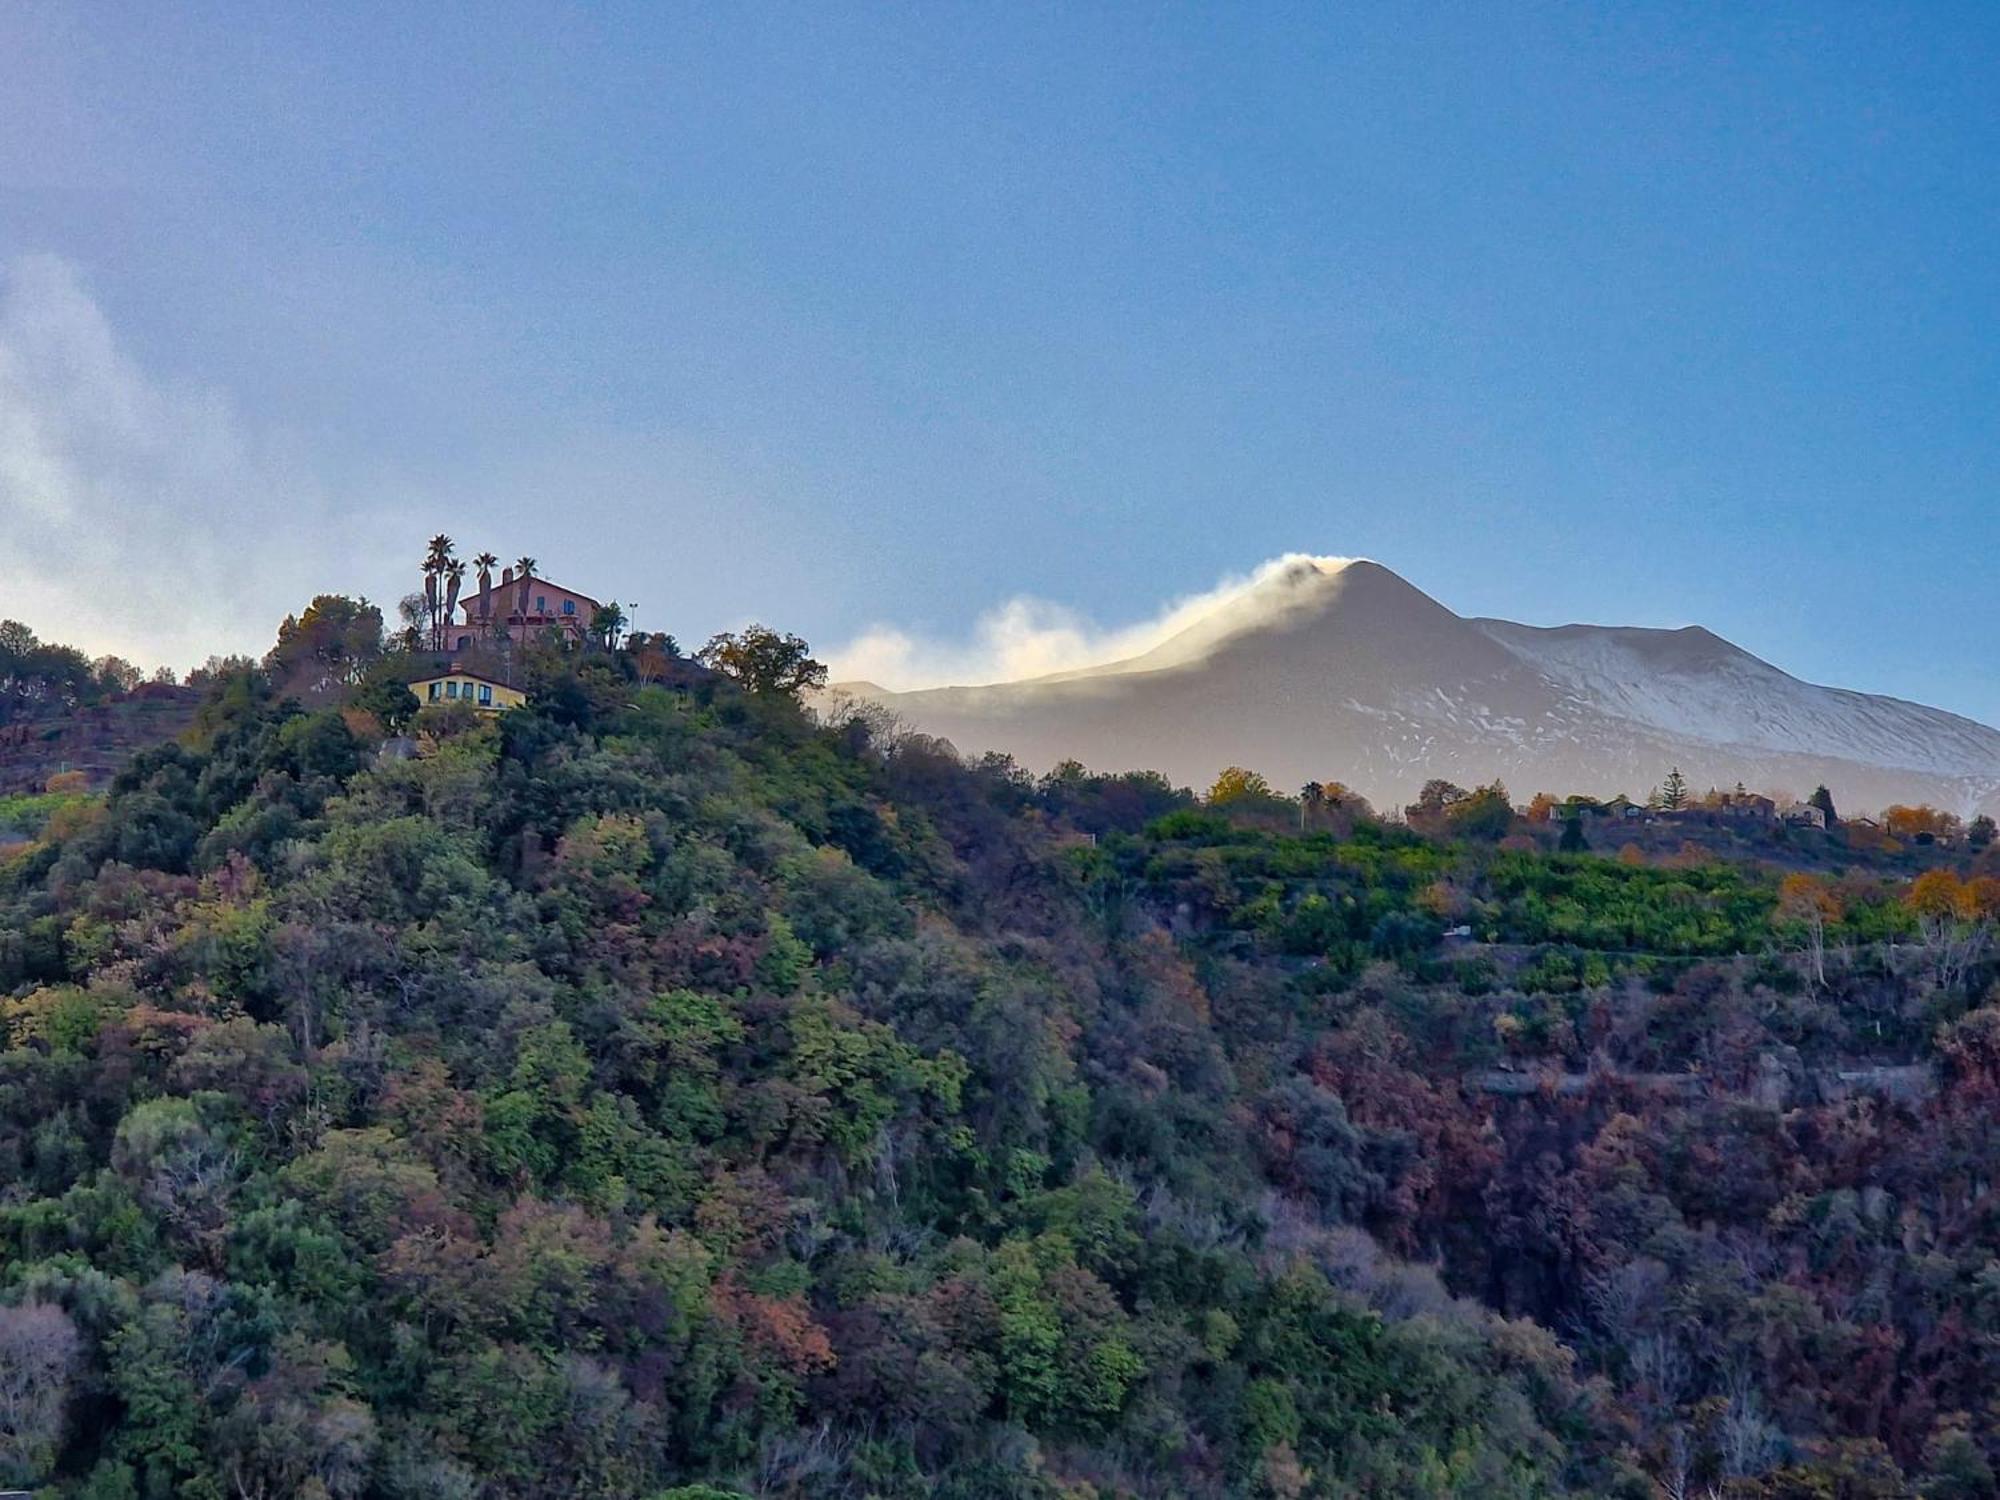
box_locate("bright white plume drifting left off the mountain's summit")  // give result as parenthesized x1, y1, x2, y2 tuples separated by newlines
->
(828, 552, 1348, 692)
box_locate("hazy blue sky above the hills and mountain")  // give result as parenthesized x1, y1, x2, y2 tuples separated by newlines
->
(0, 0, 2000, 720)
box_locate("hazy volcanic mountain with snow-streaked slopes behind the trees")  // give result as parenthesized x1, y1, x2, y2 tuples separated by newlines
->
(838, 560, 2000, 812)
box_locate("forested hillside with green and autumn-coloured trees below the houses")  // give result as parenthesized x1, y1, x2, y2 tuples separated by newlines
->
(0, 628, 2000, 1500)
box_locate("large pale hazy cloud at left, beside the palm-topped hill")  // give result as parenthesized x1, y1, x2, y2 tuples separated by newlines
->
(0, 256, 398, 666)
